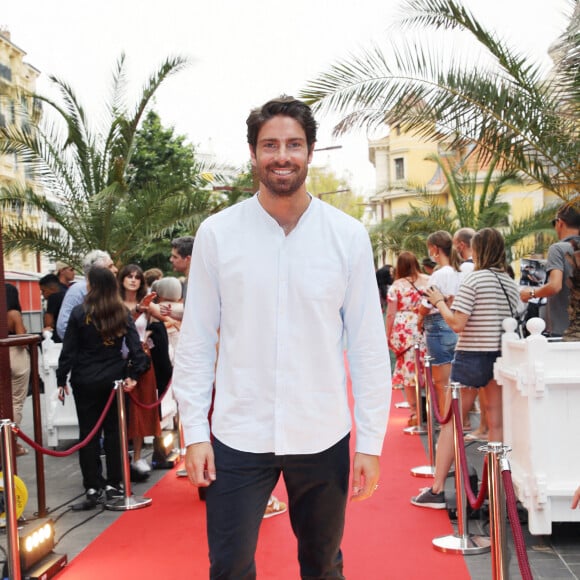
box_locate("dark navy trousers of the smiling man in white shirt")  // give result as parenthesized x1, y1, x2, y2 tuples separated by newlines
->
(206, 435, 350, 580)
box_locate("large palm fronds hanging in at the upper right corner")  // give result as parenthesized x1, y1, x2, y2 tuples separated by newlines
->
(301, 0, 580, 200)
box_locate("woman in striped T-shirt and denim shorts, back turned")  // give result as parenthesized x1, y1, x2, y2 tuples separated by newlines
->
(411, 228, 519, 509)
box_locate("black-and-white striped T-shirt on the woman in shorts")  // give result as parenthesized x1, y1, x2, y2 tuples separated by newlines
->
(452, 269, 520, 352)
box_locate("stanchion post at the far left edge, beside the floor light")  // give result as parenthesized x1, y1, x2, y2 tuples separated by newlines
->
(0, 419, 21, 580)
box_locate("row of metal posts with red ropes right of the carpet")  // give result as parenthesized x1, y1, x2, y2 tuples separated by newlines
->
(412, 350, 533, 580)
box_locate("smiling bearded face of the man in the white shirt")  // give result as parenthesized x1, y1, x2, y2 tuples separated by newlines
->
(250, 115, 312, 197)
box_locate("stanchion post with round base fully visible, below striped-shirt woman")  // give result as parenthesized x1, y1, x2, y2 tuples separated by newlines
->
(433, 382, 490, 556)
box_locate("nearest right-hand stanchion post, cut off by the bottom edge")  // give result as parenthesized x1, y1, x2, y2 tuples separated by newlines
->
(480, 441, 509, 580)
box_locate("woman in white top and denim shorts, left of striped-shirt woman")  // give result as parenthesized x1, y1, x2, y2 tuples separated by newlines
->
(419, 230, 461, 414)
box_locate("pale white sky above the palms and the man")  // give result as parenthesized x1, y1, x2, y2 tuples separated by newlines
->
(0, 0, 570, 195)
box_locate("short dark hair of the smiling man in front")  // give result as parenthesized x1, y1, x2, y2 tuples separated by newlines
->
(246, 95, 316, 151)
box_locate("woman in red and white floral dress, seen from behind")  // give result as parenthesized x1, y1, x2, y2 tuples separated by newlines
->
(387, 252, 429, 426)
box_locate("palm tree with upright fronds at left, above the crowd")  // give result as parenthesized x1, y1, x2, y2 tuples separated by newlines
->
(0, 55, 209, 267)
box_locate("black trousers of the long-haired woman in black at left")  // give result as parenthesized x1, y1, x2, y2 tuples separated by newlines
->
(73, 383, 123, 489)
